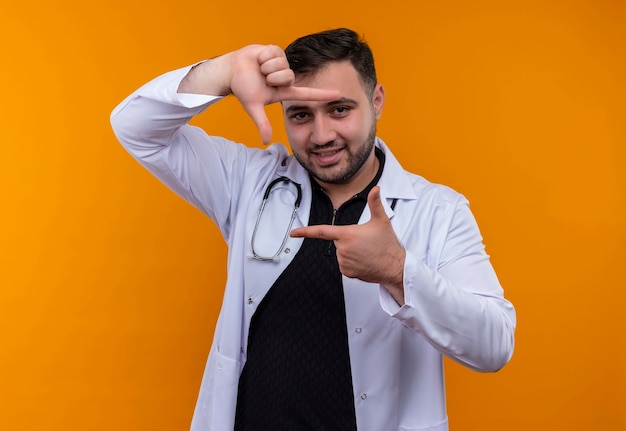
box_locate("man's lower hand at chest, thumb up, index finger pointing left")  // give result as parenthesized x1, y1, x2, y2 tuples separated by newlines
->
(291, 186, 406, 305)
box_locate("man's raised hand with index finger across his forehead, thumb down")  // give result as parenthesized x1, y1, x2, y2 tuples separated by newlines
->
(178, 45, 339, 144)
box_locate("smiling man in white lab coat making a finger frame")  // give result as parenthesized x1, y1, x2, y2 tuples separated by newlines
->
(112, 29, 515, 431)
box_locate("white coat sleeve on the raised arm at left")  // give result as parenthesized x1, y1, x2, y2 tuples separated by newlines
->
(111, 66, 261, 239)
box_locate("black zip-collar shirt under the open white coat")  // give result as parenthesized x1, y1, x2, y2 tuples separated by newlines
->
(235, 148, 384, 431)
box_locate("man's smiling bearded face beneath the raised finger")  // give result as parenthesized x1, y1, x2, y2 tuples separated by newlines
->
(283, 61, 384, 187)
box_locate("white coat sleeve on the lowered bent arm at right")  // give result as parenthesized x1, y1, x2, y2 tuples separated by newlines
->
(381, 191, 516, 372)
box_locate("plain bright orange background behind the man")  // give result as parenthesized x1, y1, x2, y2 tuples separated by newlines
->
(0, 0, 626, 431)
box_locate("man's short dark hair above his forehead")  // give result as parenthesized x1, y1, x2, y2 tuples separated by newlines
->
(285, 28, 378, 95)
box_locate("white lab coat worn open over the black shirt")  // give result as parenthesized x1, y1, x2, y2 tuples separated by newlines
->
(111, 68, 516, 431)
